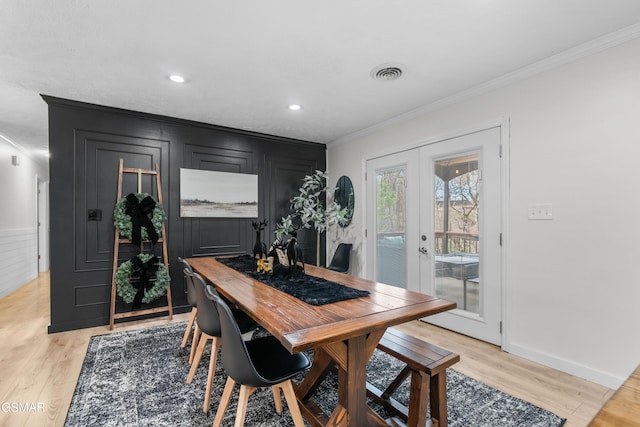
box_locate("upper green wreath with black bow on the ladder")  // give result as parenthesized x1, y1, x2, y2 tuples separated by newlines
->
(113, 193, 166, 246)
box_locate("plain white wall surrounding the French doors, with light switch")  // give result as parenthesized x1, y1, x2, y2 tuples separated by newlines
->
(327, 36, 640, 388)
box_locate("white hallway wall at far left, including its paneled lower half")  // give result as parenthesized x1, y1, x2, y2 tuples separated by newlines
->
(0, 138, 48, 298)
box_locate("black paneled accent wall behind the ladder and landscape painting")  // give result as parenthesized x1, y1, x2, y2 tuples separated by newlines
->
(43, 96, 326, 332)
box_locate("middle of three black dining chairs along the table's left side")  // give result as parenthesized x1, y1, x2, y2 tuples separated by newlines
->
(184, 269, 258, 412)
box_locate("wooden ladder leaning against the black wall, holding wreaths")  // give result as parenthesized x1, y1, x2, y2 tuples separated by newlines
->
(109, 159, 173, 329)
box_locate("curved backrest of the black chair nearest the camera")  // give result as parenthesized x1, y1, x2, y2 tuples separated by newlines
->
(208, 285, 271, 387)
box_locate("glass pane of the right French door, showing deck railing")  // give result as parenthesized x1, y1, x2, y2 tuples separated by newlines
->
(433, 153, 480, 313)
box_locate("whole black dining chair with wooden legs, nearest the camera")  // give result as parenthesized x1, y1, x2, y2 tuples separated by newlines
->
(205, 286, 311, 427)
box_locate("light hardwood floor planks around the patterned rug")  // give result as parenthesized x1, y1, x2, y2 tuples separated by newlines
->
(0, 274, 613, 427)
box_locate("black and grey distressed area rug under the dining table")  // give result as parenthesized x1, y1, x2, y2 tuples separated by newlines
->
(65, 323, 564, 427)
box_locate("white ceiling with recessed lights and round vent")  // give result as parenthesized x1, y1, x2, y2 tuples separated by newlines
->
(0, 0, 640, 160)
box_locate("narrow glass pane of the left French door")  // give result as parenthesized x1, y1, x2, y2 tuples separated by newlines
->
(376, 166, 407, 288)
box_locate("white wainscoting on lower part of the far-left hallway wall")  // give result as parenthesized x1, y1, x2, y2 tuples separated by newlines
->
(0, 228, 38, 298)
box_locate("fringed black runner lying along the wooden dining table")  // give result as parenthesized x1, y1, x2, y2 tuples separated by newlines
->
(216, 255, 369, 305)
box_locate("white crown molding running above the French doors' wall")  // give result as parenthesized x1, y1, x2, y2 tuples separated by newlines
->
(327, 23, 640, 147)
